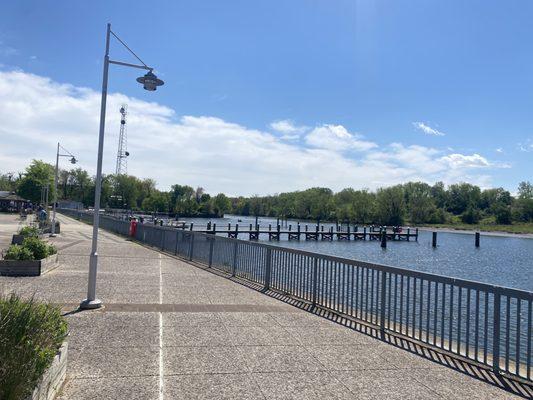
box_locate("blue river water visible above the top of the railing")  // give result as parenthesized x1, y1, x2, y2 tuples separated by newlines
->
(171, 216, 533, 291)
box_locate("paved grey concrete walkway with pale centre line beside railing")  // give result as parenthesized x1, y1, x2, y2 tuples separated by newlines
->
(0, 216, 528, 400)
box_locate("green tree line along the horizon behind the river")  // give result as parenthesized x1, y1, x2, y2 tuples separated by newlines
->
(0, 160, 533, 225)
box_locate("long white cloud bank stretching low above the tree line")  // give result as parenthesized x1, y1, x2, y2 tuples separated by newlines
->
(0, 71, 497, 195)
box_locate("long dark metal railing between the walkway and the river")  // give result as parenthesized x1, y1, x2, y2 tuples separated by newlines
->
(60, 210, 533, 381)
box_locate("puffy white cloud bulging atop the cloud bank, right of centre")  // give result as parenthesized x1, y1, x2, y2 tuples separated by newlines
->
(305, 124, 377, 152)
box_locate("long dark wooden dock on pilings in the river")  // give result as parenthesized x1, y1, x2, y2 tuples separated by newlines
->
(178, 223, 418, 242)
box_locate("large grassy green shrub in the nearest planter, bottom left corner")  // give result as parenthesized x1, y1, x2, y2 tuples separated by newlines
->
(0, 294, 67, 400)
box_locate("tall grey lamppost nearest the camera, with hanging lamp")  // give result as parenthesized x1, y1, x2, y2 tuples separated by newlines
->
(80, 24, 164, 309)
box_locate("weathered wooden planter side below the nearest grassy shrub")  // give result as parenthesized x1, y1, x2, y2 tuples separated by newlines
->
(25, 340, 68, 400)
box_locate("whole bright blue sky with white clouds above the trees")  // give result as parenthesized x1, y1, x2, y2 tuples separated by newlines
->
(0, 0, 533, 194)
